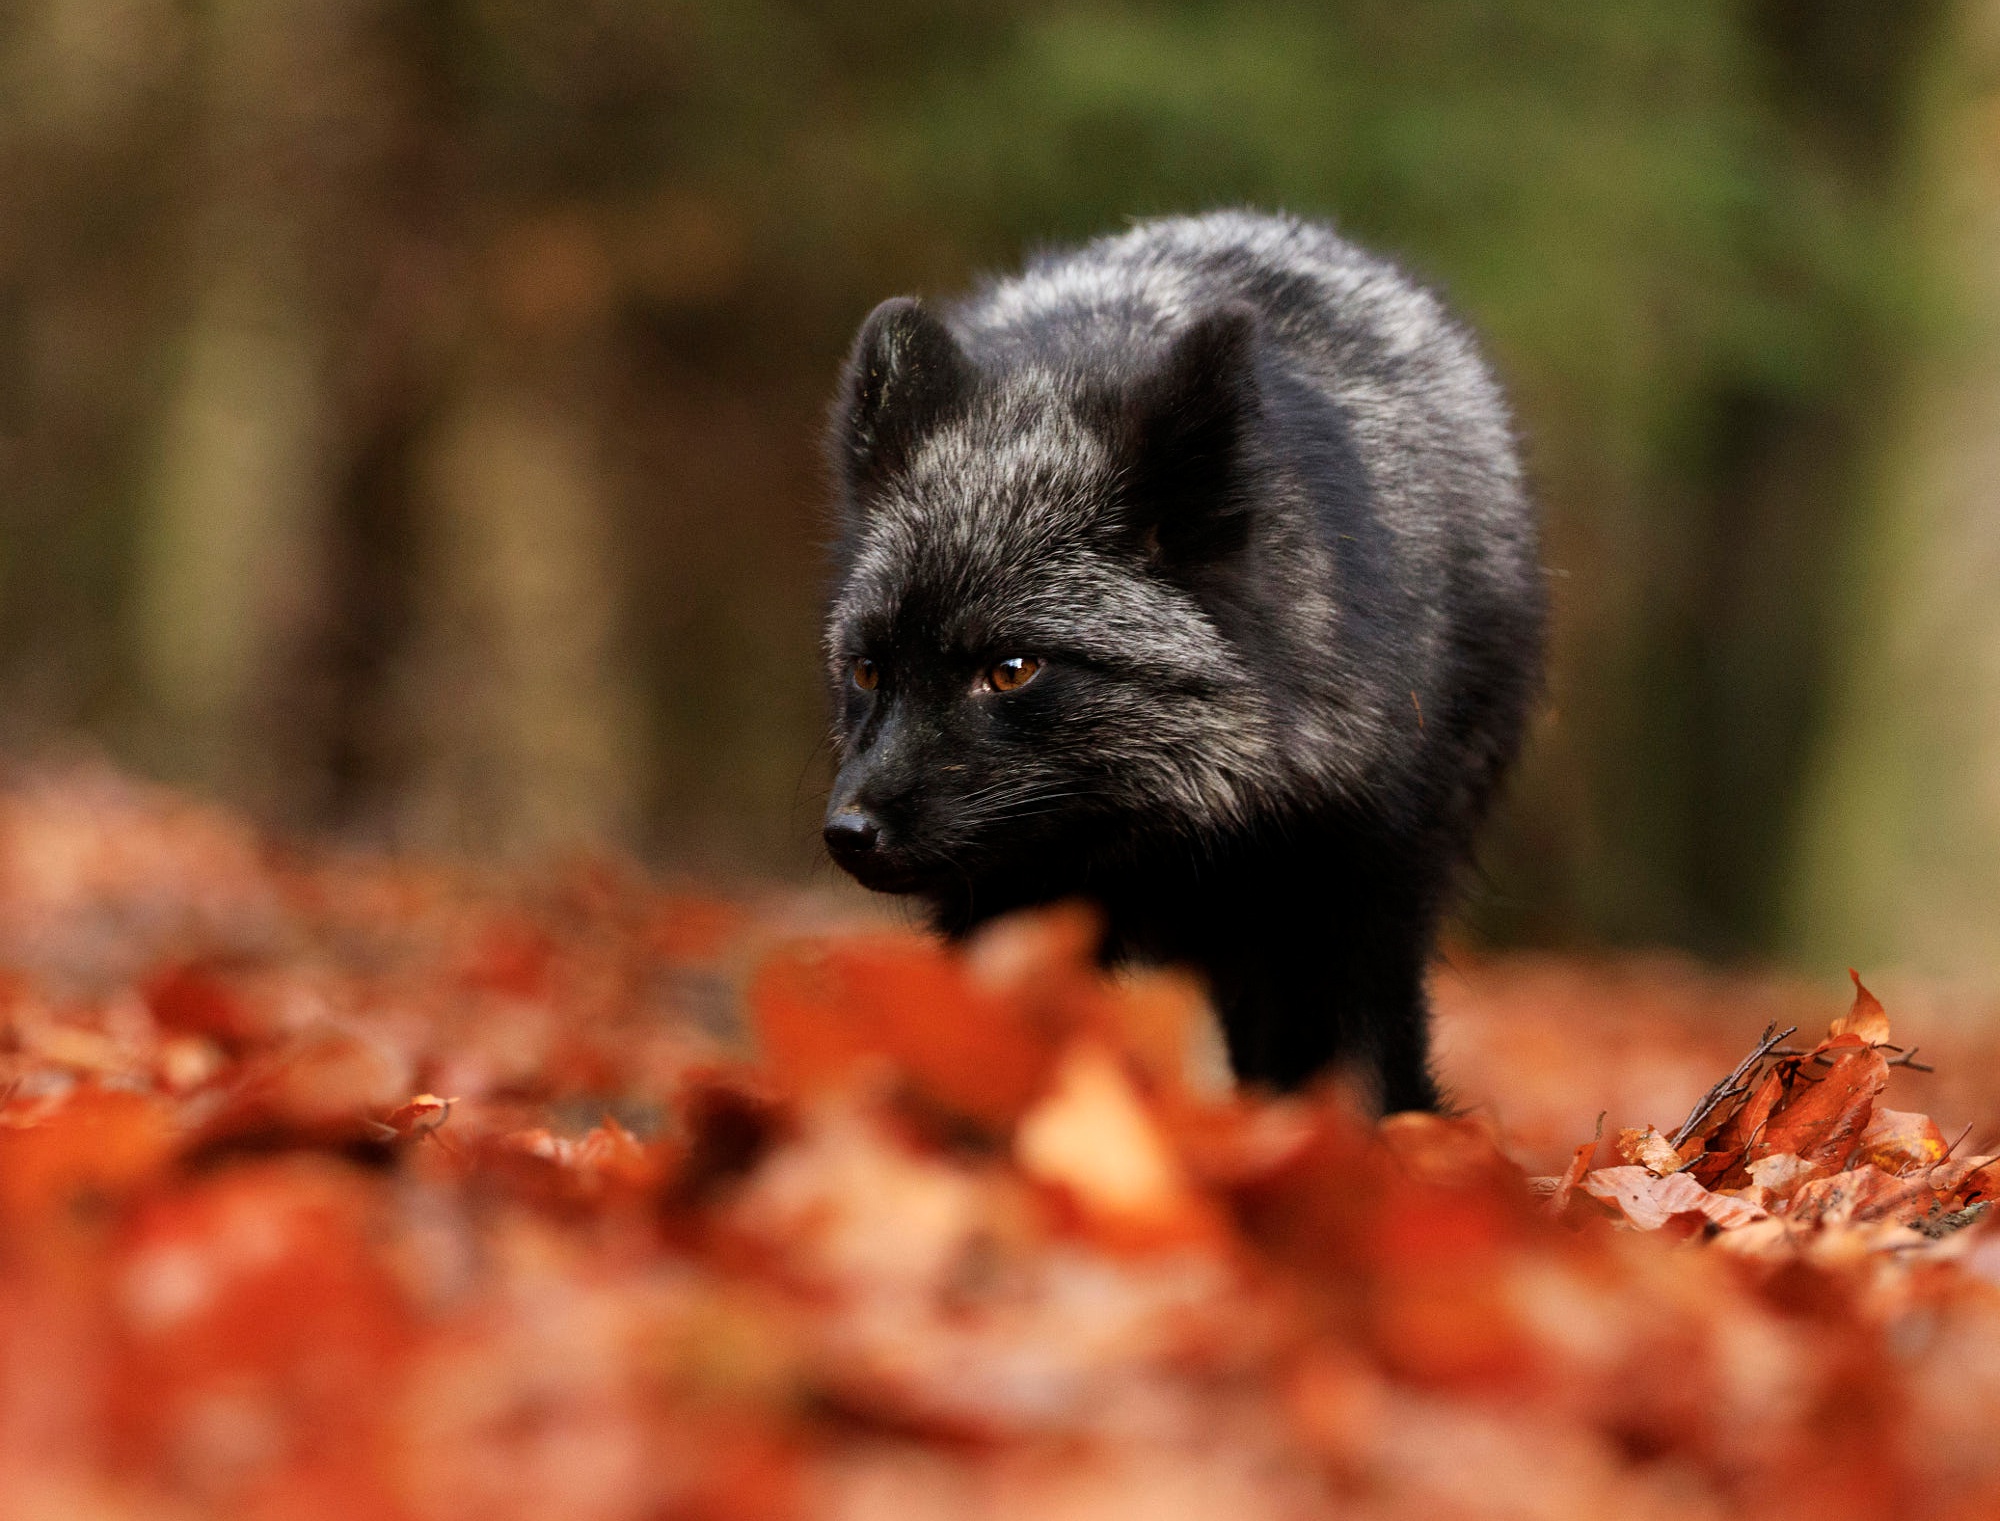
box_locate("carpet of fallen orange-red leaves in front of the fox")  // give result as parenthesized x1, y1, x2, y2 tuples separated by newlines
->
(0, 777, 2000, 1521)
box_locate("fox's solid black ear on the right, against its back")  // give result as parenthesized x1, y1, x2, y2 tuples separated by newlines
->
(1124, 302, 1258, 564)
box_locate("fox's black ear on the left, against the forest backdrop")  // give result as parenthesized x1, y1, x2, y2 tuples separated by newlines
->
(834, 296, 972, 502)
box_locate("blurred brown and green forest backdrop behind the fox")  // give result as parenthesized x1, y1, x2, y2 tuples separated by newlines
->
(0, 0, 2000, 975)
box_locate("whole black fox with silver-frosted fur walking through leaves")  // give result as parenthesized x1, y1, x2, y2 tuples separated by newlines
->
(826, 212, 1544, 1109)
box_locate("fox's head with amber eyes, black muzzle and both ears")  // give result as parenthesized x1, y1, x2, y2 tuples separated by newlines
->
(826, 298, 1312, 893)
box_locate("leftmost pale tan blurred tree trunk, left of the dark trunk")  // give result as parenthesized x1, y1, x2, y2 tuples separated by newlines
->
(132, 0, 394, 813)
